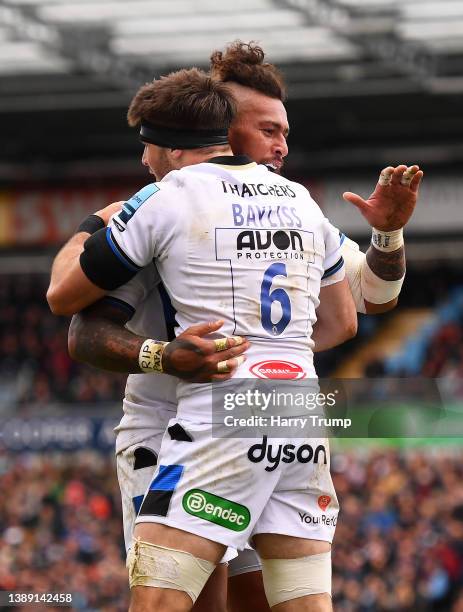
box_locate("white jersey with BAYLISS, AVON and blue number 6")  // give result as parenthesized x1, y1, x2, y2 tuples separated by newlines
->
(81, 157, 344, 412)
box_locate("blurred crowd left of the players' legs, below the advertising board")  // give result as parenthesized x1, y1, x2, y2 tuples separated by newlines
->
(0, 451, 128, 612)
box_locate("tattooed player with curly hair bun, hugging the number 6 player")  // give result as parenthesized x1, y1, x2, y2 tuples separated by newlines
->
(49, 42, 422, 612)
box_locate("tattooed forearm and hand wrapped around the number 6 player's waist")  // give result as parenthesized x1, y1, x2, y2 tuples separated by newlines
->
(68, 300, 249, 382)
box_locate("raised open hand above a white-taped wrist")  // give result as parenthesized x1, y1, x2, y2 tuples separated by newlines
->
(342, 165, 423, 232)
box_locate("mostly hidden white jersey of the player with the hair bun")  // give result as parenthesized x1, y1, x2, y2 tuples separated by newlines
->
(105, 264, 178, 453)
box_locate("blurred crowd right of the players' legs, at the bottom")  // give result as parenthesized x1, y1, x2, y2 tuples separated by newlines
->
(333, 448, 463, 612)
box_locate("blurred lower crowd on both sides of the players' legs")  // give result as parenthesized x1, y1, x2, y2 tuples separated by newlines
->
(0, 447, 463, 612)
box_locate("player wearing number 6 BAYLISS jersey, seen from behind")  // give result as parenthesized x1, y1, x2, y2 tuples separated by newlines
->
(47, 64, 356, 610)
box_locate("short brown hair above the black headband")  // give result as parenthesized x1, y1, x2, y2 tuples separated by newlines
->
(127, 68, 235, 130)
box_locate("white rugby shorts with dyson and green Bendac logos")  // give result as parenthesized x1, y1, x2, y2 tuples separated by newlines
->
(136, 418, 339, 550)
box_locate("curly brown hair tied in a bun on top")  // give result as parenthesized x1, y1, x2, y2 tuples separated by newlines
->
(210, 40, 286, 102)
